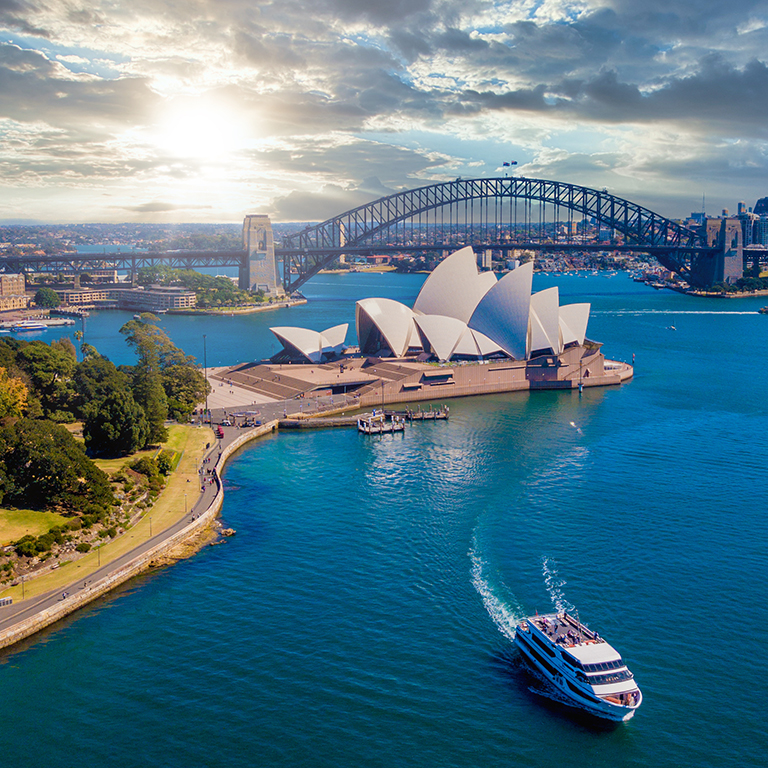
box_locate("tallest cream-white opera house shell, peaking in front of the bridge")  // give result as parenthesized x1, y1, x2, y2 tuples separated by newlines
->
(413, 246, 496, 323)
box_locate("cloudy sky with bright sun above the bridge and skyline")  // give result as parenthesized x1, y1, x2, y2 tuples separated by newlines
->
(0, 0, 768, 223)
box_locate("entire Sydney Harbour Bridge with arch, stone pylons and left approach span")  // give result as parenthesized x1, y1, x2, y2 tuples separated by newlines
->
(2, 177, 743, 292)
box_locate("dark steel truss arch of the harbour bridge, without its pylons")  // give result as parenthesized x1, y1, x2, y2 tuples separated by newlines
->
(275, 176, 713, 290)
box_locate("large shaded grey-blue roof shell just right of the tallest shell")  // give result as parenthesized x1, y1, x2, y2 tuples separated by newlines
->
(469, 262, 533, 360)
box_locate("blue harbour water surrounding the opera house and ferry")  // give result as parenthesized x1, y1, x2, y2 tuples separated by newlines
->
(0, 275, 768, 768)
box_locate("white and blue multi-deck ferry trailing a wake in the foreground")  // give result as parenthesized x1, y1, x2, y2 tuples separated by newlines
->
(515, 612, 643, 721)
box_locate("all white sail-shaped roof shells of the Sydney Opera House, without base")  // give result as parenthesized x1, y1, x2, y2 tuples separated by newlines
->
(271, 247, 589, 363)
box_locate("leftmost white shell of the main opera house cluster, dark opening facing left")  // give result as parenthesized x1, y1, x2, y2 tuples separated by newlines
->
(355, 299, 421, 357)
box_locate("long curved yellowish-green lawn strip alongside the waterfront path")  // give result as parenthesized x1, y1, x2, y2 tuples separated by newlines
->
(0, 424, 215, 602)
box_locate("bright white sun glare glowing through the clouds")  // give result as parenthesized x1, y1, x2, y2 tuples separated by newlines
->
(152, 99, 247, 160)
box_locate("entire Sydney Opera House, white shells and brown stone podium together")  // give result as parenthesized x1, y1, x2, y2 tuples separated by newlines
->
(214, 248, 632, 406)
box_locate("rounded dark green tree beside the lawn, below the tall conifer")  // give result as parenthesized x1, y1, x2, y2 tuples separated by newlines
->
(83, 386, 149, 456)
